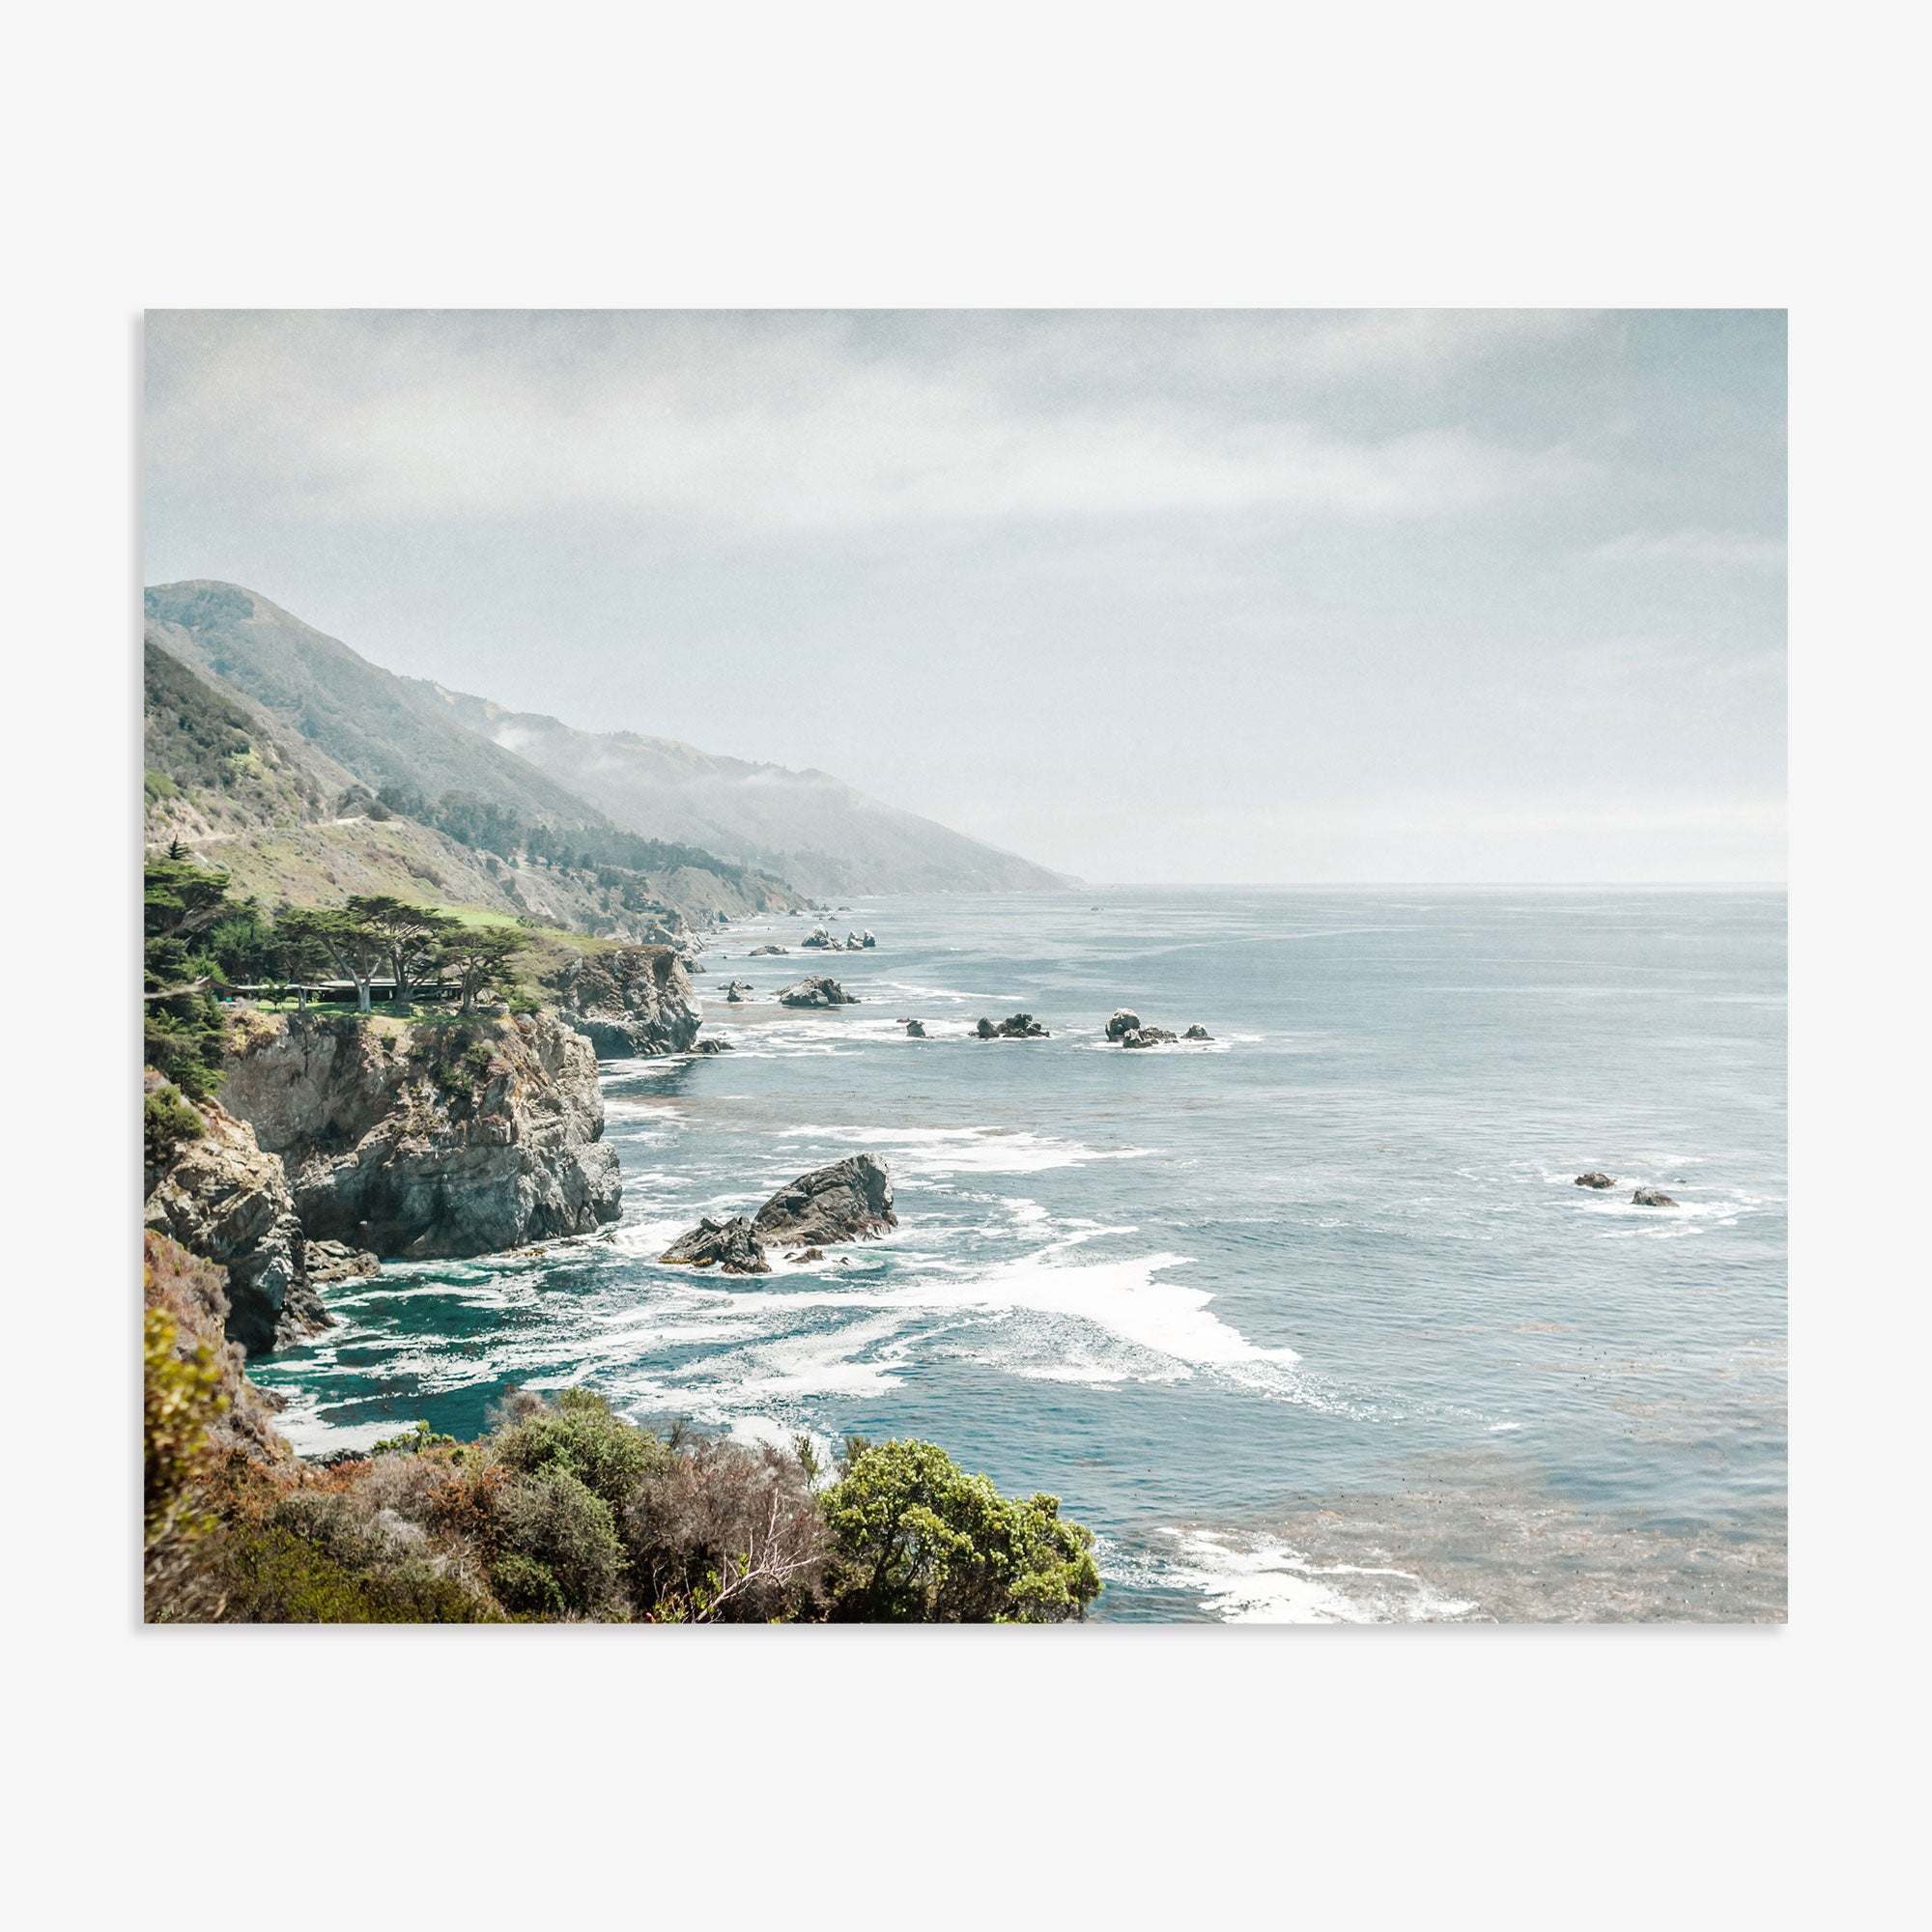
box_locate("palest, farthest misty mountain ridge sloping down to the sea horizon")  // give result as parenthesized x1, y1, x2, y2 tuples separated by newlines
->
(421, 684, 1070, 896)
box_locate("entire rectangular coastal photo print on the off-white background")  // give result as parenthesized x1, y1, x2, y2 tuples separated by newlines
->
(139, 309, 1787, 1642)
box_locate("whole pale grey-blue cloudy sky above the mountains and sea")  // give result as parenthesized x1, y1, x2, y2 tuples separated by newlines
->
(145, 311, 1785, 883)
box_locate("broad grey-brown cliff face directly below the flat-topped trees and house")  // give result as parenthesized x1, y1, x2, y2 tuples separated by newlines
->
(220, 1014, 618, 1258)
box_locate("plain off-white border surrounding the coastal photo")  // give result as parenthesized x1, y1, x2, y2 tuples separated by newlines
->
(4, 0, 1928, 1926)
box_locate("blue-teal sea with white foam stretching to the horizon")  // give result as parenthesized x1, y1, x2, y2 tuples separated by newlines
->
(255, 889, 1787, 1621)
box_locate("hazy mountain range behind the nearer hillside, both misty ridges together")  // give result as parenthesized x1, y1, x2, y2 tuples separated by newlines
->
(147, 580, 1068, 895)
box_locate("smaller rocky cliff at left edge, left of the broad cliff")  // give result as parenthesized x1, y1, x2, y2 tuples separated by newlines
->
(141, 1074, 328, 1354)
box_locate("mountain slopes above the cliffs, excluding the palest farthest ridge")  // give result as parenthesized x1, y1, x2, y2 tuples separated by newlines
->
(143, 583, 798, 935)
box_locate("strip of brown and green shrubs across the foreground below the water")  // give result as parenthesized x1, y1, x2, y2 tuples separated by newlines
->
(143, 1235, 1099, 1623)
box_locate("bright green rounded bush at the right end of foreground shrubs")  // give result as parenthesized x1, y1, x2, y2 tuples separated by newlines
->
(823, 1441, 1099, 1623)
